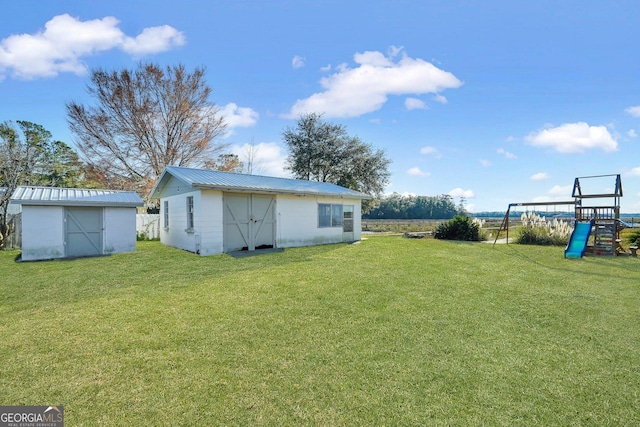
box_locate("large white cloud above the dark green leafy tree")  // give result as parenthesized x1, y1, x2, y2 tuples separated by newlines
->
(287, 48, 462, 118)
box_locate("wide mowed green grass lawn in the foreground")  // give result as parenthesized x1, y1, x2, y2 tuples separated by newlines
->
(0, 237, 640, 426)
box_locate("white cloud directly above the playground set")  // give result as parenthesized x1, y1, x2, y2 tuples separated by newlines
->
(527, 122, 618, 153)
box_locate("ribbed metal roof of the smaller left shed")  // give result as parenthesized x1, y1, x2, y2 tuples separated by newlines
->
(11, 186, 144, 207)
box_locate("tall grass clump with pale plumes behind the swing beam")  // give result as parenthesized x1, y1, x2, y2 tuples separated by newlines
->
(516, 212, 573, 246)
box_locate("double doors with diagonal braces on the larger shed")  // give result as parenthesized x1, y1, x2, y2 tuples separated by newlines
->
(224, 193, 276, 252)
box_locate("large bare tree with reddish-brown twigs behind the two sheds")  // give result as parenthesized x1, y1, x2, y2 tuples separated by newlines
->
(67, 63, 226, 194)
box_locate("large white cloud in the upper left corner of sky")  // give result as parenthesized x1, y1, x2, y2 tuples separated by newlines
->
(0, 14, 185, 79)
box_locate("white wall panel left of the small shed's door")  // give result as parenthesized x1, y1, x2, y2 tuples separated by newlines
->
(22, 205, 65, 261)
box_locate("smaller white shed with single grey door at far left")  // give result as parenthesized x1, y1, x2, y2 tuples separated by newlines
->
(11, 186, 143, 261)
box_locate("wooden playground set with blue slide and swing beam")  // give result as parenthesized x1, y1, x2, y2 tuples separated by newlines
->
(493, 174, 638, 258)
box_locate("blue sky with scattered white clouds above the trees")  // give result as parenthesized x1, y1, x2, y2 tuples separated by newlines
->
(0, 0, 640, 212)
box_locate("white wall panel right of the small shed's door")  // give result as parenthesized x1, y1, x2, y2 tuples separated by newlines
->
(104, 208, 136, 254)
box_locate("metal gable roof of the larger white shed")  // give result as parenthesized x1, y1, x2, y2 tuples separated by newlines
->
(150, 166, 371, 199)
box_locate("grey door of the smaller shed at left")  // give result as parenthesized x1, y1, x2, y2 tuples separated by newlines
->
(64, 207, 102, 257)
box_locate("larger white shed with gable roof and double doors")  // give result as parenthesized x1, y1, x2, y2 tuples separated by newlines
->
(151, 166, 370, 255)
